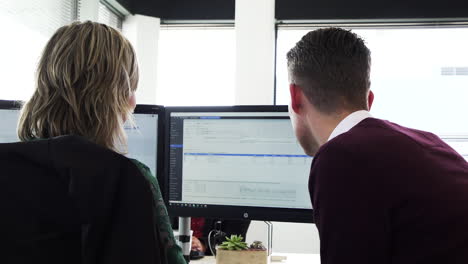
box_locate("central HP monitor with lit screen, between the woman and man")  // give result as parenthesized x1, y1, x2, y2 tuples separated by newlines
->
(166, 106, 313, 223)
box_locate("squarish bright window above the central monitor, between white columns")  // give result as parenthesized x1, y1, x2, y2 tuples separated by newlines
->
(156, 25, 236, 106)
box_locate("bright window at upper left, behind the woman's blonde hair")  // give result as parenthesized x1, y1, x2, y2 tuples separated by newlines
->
(0, 0, 77, 100)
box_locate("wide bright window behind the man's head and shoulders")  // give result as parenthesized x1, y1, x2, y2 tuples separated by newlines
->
(276, 25, 468, 158)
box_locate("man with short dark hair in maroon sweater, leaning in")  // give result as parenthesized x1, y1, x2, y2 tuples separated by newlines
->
(287, 28, 468, 264)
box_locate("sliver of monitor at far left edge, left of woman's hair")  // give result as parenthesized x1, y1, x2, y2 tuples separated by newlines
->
(0, 100, 21, 143)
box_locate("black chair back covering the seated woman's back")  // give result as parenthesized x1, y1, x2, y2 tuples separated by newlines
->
(0, 136, 166, 264)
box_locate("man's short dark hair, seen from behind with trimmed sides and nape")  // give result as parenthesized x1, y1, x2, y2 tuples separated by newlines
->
(287, 28, 370, 114)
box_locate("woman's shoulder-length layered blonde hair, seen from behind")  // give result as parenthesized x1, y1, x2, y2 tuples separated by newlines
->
(18, 21, 138, 153)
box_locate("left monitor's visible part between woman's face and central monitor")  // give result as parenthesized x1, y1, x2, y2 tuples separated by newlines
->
(125, 105, 164, 181)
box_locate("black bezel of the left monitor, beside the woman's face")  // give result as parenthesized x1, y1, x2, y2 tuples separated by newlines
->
(133, 104, 166, 195)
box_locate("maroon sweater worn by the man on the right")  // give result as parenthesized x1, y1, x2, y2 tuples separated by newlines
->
(309, 118, 468, 264)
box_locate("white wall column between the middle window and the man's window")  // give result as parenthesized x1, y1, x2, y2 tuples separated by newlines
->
(235, 0, 275, 105)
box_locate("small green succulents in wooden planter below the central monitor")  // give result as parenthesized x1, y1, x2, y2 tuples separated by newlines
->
(216, 235, 268, 264)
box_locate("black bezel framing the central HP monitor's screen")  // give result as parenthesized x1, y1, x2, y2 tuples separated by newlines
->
(164, 105, 314, 223)
